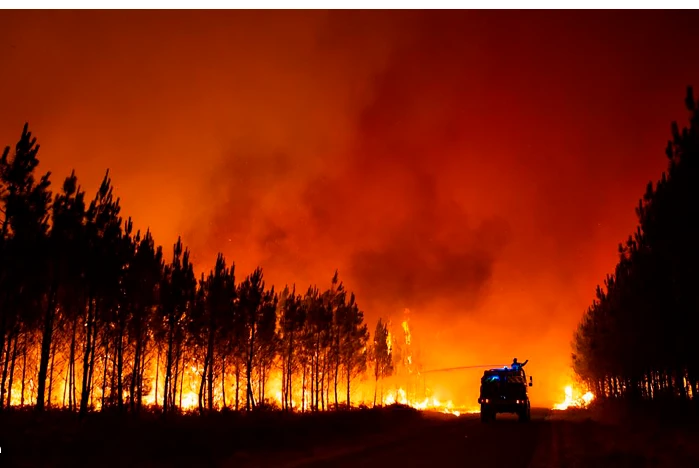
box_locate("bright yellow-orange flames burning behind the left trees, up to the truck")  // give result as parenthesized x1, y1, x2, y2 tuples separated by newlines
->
(2, 310, 479, 416)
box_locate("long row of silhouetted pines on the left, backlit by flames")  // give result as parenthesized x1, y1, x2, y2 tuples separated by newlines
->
(0, 125, 393, 414)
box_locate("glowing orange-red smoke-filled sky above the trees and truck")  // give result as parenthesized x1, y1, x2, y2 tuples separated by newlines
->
(0, 11, 699, 404)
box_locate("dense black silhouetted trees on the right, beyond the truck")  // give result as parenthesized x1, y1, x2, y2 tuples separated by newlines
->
(573, 87, 699, 400)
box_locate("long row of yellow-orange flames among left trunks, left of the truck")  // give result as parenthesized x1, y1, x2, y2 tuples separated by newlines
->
(5, 319, 480, 416)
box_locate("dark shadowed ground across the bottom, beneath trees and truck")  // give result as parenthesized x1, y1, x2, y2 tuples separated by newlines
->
(0, 407, 699, 468)
